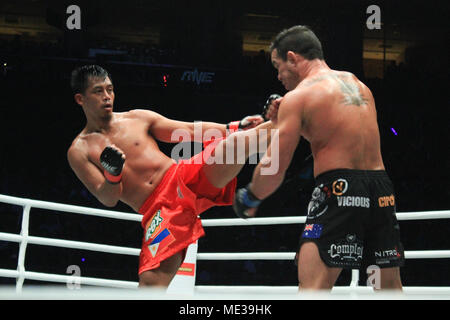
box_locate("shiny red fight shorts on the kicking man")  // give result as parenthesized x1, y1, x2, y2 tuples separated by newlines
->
(139, 140, 237, 274)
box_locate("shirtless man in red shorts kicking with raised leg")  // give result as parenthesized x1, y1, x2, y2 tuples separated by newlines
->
(67, 66, 278, 287)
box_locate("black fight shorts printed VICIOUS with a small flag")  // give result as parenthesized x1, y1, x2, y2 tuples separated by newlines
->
(296, 169, 404, 269)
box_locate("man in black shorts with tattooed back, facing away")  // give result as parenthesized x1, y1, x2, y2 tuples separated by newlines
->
(233, 26, 404, 289)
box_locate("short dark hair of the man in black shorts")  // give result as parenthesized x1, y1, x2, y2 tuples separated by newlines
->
(270, 26, 323, 61)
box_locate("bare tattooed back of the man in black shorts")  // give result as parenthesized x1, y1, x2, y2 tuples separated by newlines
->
(296, 71, 384, 176)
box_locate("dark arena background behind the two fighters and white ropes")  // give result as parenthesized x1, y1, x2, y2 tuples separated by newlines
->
(0, 0, 450, 292)
